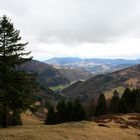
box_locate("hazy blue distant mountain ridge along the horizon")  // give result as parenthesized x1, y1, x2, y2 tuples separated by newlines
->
(44, 57, 140, 74)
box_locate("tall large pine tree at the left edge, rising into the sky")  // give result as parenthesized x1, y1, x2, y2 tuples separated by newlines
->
(0, 16, 35, 127)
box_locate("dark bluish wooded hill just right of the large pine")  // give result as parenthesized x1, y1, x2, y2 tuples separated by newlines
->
(18, 60, 69, 87)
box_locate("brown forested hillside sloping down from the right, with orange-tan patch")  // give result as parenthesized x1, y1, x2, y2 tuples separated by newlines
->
(62, 65, 140, 101)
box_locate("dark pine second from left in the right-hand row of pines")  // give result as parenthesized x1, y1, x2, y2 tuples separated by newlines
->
(109, 90, 120, 113)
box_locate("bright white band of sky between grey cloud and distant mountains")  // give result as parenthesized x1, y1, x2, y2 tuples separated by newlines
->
(30, 38, 140, 60)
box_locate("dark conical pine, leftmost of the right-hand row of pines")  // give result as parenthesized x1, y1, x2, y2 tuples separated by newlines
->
(94, 94, 107, 116)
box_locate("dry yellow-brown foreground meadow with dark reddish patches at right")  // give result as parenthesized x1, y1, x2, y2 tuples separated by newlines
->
(0, 114, 140, 140)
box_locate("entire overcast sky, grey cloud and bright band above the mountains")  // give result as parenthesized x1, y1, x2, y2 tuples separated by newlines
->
(0, 0, 140, 60)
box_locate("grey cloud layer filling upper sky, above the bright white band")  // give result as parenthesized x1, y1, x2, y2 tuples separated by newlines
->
(0, 0, 140, 43)
